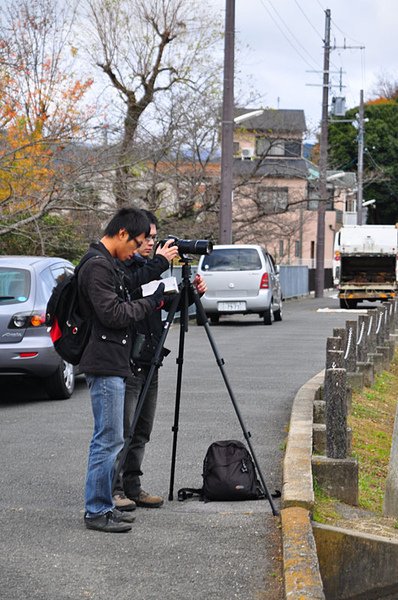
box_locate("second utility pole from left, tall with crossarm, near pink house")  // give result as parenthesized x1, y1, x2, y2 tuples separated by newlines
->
(315, 8, 330, 298)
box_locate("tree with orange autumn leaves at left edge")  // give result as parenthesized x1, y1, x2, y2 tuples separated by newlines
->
(0, 0, 92, 251)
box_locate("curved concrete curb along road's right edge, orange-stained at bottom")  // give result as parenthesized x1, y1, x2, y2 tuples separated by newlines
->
(281, 371, 325, 600)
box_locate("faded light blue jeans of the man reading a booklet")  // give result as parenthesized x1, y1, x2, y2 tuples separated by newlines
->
(85, 375, 126, 517)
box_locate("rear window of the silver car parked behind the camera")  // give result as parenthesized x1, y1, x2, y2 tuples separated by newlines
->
(202, 248, 262, 271)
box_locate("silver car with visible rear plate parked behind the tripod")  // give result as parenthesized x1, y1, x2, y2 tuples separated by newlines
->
(198, 244, 282, 325)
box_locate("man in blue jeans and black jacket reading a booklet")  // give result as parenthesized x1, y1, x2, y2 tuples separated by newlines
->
(78, 208, 164, 532)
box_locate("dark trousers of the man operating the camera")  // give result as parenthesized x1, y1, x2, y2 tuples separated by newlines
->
(115, 368, 158, 498)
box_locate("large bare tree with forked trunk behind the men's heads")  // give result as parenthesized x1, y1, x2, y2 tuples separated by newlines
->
(87, 0, 219, 205)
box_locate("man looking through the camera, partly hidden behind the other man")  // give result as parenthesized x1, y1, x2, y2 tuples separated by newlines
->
(113, 211, 206, 511)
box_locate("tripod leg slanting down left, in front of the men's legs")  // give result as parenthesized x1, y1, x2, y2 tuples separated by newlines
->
(112, 294, 181, 489)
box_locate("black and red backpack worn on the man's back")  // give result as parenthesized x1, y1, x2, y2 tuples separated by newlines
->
(46, 253, 95, 365)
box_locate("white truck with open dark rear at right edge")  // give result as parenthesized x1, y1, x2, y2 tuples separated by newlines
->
(333, 225, 398, 308)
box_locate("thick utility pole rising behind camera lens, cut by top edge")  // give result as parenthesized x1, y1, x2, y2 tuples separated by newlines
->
(219, 0, 235, 244)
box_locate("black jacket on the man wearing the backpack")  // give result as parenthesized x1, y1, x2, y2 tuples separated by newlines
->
(78, 242, 153, 377)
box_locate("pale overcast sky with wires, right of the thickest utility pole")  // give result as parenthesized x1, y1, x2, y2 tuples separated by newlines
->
(208, 0, 398, 137)
